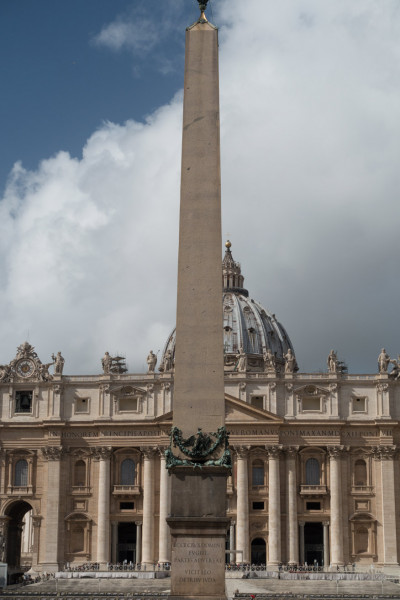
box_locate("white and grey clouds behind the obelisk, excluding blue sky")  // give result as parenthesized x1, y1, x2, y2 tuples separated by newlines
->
(0, 0, 400, 373)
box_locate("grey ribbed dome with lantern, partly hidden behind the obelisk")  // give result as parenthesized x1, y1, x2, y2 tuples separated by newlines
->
(160, 241, 294, 371)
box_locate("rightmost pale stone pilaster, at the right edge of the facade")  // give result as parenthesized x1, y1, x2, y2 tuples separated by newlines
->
(379, 446, 398, 566)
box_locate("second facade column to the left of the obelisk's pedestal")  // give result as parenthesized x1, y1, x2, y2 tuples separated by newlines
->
(141, 448, 155, 565)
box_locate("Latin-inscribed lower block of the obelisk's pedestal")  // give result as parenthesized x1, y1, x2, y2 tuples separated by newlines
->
(172, 536, 225, 595)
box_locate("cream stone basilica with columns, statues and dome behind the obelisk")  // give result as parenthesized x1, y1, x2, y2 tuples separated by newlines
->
(0, 243, 400, 572)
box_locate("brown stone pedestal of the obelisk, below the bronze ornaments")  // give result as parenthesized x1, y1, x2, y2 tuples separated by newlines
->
(167, 467, 230, 600)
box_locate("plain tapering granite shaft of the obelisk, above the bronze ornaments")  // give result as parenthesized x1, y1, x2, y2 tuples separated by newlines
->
(173, 22, 224, 435)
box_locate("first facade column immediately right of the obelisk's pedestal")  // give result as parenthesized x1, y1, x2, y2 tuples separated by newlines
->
(236, 448, 250, 563)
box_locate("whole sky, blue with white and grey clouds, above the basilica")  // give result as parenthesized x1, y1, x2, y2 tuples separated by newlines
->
(0, 0, 400, 374)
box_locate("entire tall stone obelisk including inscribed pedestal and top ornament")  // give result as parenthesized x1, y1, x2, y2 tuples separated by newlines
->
(167, 0, 230, 600)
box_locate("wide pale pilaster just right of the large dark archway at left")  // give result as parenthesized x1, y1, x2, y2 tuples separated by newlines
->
(42, 446, 64, 573)
